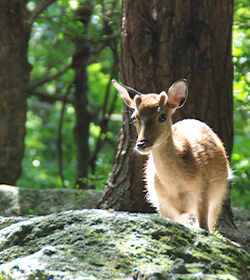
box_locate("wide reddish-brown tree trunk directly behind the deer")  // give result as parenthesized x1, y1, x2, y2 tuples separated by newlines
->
(99, 0, 233, 228)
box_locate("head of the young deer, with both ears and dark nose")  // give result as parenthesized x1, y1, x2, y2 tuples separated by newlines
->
(112, 79, 188, 155)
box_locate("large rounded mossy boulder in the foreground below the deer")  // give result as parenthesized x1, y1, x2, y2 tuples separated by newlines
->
(0, 209, 250, 280)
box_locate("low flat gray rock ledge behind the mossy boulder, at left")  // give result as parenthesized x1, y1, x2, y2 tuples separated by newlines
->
(0, 185, 102, 216)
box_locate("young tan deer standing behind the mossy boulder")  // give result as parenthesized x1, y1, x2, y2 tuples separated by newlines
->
(113, 79, 230, 231)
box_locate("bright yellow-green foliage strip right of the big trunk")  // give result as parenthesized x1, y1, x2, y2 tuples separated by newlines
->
(232, 1, 250, 208)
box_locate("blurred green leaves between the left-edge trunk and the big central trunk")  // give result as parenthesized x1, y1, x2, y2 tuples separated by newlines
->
(18, 0, 122, 188)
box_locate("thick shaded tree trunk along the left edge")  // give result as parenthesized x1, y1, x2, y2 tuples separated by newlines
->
(0, 0, 31, 185)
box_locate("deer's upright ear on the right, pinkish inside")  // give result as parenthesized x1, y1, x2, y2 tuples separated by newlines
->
(168, 79, 188, 109)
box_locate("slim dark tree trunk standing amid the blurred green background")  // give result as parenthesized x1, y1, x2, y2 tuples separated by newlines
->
(73, 6, 93, 188)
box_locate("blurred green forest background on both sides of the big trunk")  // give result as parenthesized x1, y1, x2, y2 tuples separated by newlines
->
(14, 0, 250, 208)
